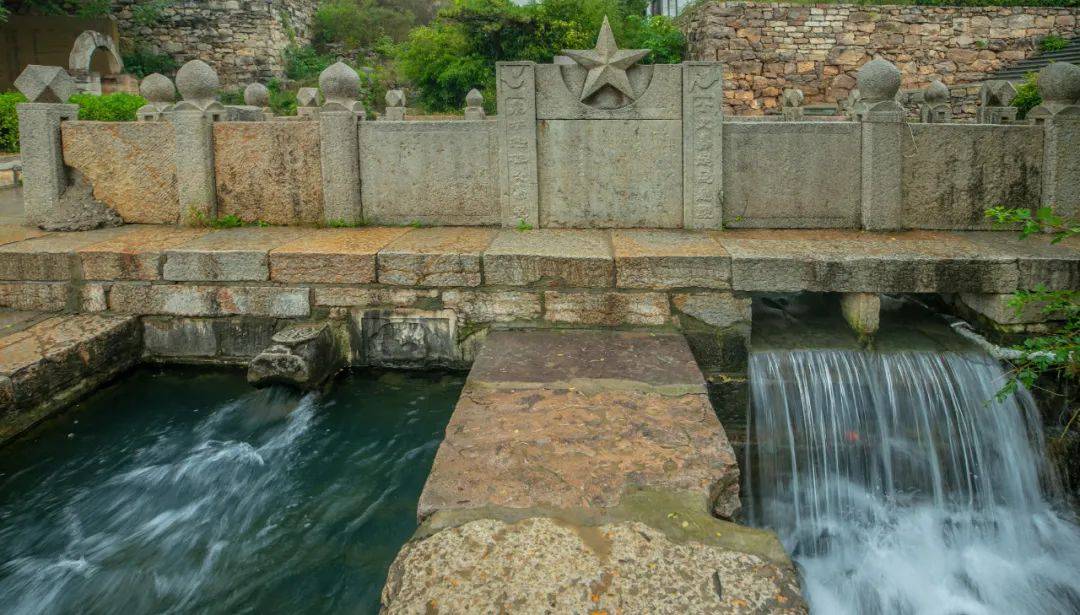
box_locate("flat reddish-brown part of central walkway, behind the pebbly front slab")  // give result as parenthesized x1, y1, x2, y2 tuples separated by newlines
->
(418, 331, 739, 519)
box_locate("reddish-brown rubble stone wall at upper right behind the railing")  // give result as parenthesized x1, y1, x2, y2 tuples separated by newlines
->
(684, 2, 1080, 115)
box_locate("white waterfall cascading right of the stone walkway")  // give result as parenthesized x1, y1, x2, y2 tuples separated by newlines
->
(745, 350, 1080, 615)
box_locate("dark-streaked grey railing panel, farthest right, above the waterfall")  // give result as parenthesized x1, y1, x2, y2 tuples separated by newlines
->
(903, 124, 1043, 229)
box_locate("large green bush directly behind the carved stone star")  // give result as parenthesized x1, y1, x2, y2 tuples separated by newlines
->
(397, 0, 686, 112)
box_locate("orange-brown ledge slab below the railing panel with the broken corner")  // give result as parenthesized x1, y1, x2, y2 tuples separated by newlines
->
(77, 225, 211, 280)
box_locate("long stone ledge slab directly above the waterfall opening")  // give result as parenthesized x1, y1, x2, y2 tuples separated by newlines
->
(714, 229, 1018, 293)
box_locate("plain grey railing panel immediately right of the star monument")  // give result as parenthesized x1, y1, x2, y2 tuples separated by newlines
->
(724, 122, 862, 228)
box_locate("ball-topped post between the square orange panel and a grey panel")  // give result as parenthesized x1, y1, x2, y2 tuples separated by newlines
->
(318, 62, 364, 224)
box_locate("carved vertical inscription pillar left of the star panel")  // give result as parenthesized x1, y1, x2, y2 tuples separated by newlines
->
(495, 62, 540, 227)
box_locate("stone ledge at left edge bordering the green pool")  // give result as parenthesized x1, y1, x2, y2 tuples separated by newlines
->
(0, 312, 143, 444)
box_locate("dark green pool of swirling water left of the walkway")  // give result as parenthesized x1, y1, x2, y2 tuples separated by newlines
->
(0, 367, 463, 615)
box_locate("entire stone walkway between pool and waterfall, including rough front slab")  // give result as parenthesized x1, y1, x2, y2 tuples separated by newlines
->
(383, 331, 805, 613)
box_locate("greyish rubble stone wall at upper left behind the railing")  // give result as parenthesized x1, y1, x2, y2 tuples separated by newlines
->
(113, 0, 319, 88)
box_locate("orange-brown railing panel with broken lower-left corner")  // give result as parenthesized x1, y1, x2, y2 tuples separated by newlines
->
(60, 121, 179, 224)
